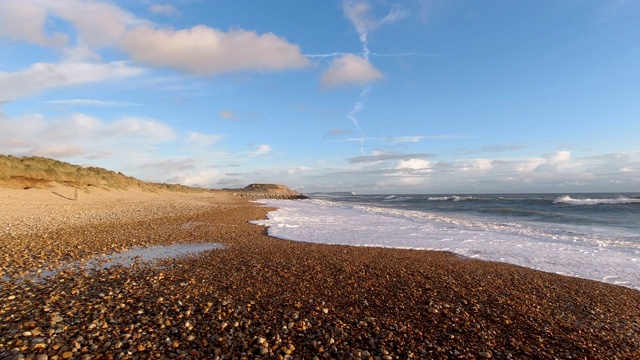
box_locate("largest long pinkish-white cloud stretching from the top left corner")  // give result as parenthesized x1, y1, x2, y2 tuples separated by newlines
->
(0, 0, 309, 75)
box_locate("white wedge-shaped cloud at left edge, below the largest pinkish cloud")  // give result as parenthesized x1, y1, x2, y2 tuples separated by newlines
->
(0, 61, 142, 103)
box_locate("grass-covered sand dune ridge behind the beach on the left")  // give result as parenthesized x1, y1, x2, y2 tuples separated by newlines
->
(0, 155, 210, 192)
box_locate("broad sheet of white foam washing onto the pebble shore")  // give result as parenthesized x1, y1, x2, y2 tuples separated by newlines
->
(253, 199, 640, 290)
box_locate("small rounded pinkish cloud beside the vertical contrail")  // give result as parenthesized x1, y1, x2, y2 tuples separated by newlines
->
(321, 54, 382, 87)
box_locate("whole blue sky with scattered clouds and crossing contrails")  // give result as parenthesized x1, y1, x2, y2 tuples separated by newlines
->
(0, 0, 640, 194)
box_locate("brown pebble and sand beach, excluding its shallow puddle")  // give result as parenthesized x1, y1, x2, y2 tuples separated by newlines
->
(0, 189, 640, 359)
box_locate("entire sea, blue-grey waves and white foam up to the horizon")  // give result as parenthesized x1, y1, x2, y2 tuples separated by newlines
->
(252, 193, 640, 290)
